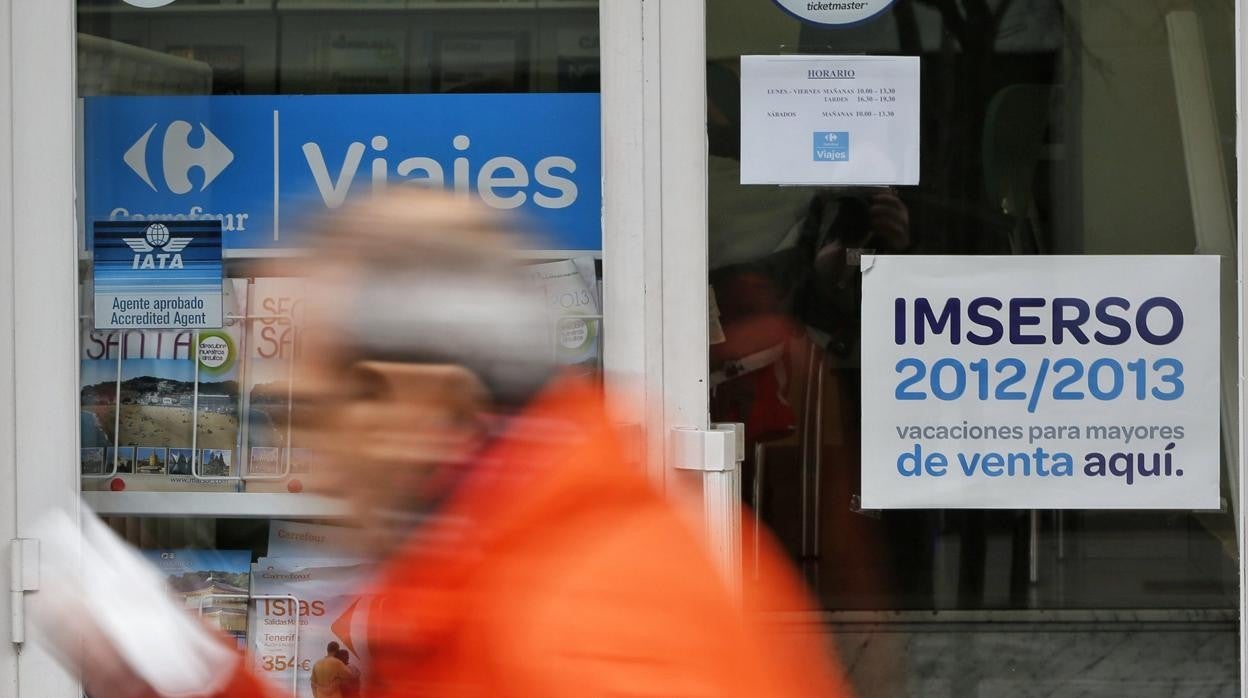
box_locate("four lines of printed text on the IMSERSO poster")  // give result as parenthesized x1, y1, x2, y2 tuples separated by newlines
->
(894, 296, 1184, 484)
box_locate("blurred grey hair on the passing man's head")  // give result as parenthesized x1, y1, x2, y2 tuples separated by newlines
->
(304, 190, 555, 406)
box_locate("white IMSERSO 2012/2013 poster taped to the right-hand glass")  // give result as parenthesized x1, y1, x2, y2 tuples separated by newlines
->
(862, 255, 1221, 509)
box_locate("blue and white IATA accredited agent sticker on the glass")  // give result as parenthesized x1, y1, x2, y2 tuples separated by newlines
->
(92, 220, 222, 330)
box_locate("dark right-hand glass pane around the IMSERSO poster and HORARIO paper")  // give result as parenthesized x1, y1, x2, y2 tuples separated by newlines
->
(706, 0, 1241, 696)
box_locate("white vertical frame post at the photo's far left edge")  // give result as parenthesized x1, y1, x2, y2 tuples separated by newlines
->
(0, 0, 81, 697)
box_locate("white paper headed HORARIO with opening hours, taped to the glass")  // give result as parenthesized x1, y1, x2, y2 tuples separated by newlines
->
(741, 56, 919, 185)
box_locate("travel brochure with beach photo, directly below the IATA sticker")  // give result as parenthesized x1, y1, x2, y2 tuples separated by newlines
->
(79, 278, 247, 492)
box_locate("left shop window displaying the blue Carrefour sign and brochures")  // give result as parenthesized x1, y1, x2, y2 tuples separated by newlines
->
(77, 0, 603, 696)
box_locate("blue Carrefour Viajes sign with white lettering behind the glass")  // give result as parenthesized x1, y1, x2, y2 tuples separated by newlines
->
(84, 94, 602, 250)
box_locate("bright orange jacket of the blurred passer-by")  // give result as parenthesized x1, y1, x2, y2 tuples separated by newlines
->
(220, 383, 849, 698)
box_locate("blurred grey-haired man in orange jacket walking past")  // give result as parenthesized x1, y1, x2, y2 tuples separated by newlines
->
(51, 189, 847, 698)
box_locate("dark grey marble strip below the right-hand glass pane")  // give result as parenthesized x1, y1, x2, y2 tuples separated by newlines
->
(832, 622, 1239, 698)
